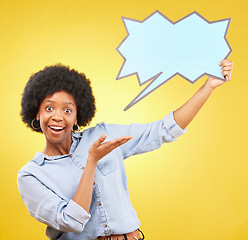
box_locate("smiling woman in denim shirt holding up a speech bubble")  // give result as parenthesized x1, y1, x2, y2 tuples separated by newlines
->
(18, 60, 232, 240)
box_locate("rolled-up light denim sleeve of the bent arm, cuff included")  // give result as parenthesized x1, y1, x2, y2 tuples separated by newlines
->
(17, 171, 90, 232)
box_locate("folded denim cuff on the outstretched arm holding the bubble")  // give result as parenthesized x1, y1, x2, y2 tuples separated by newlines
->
(163, 111, 187, 138)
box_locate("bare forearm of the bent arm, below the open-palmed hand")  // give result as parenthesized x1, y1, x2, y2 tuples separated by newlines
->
(72, 159, 97, 213)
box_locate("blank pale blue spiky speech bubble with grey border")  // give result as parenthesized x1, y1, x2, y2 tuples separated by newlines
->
(116, 10, 232, 111)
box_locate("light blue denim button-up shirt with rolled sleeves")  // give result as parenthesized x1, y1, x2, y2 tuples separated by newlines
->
(17, 112, 186, 240)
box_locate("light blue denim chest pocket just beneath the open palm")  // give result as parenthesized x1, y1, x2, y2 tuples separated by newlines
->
(97, 150, 117, 176)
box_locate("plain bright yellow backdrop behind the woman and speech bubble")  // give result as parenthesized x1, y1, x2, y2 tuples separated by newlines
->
(0, 0, 248, 240)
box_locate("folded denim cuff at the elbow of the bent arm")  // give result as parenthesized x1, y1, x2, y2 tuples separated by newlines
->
(65, 200, 91, 225)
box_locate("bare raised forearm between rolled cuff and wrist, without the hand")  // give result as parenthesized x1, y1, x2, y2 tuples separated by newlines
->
(174, 82, 214, 129)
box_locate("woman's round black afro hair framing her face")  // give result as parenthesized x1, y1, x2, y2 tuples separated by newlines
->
(21, 64, 96, 132)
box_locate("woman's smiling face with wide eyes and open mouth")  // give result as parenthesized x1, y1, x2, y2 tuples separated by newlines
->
(37, 91, 77, 148)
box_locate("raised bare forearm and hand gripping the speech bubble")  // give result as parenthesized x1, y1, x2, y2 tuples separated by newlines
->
(174, 59, 233, 129)
